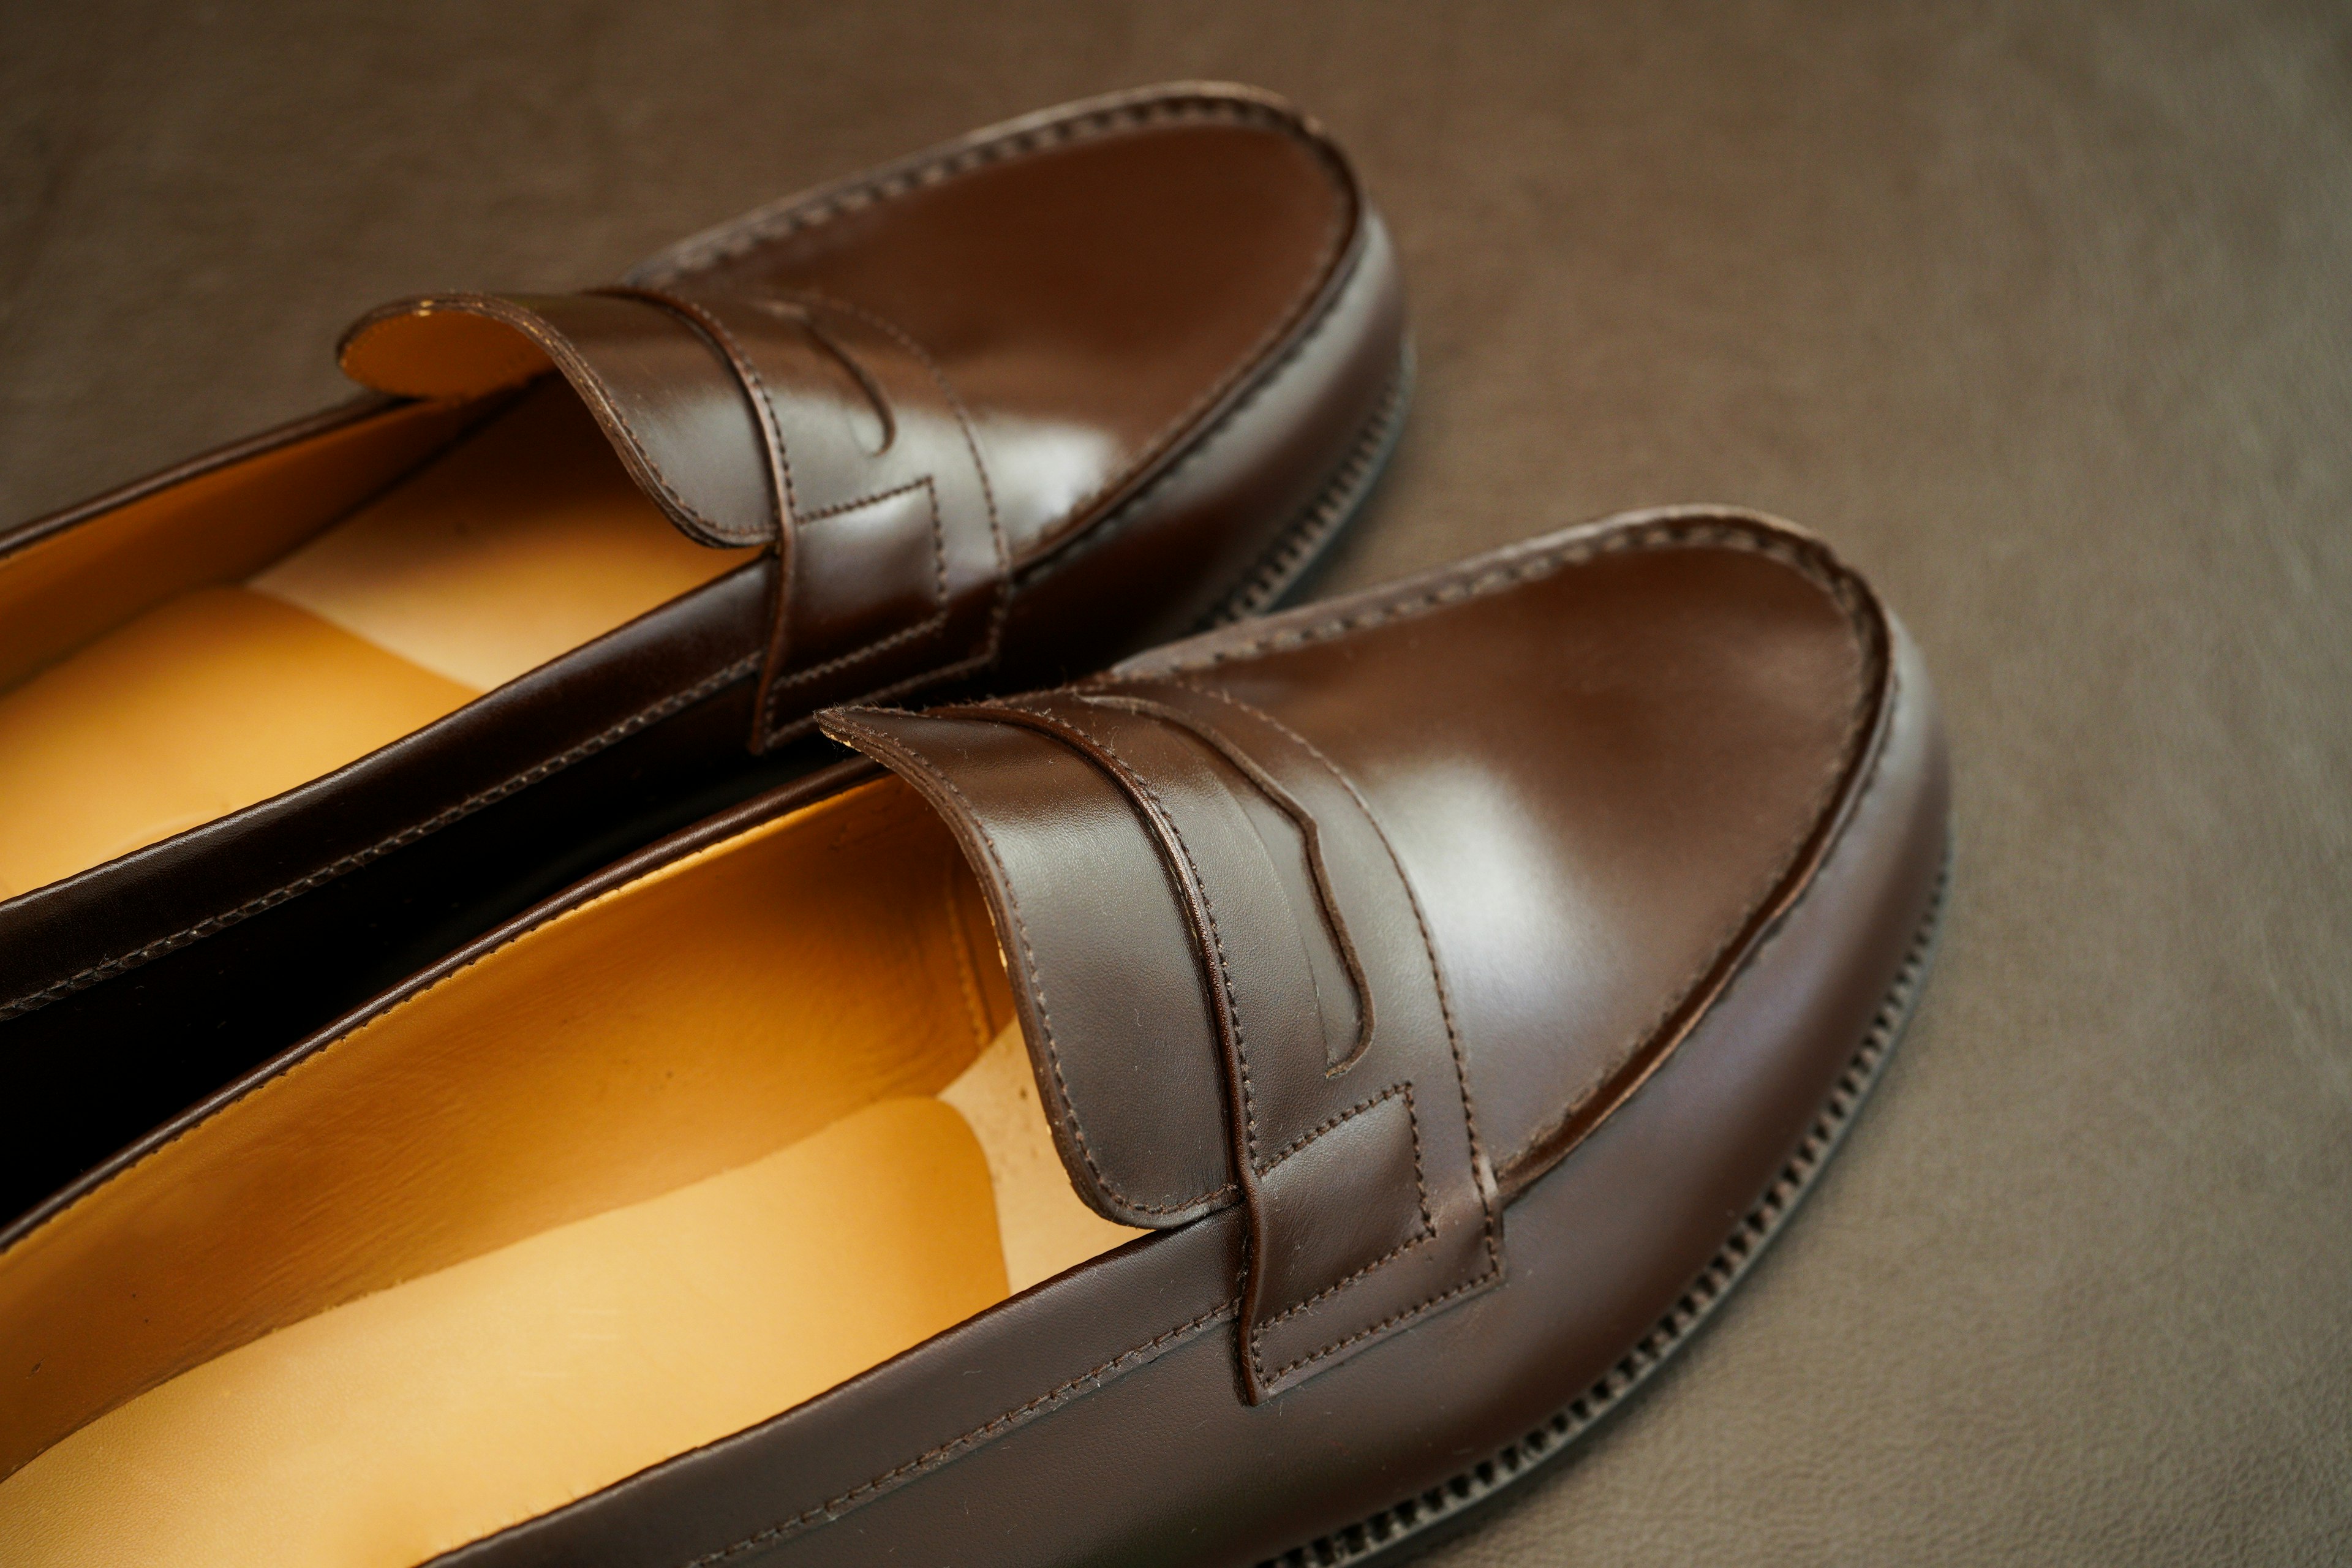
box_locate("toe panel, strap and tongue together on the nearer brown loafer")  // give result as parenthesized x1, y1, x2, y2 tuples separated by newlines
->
(826, 515, 1887, 1399)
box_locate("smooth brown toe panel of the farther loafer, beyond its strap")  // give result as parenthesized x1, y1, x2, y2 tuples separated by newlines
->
(630, 89, 1362, 557)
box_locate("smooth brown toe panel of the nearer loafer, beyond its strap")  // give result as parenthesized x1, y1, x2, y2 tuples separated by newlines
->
(1143, 526, 1887, 1170)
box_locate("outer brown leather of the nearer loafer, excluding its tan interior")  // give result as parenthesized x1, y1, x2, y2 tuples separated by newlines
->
(320, 510, 1950, 1568)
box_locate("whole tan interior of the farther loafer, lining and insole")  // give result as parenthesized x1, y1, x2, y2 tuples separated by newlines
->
(0, 379, 750, 898)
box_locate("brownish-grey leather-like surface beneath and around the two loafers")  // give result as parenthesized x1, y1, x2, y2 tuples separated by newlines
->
(0, 0, 2352, 1568)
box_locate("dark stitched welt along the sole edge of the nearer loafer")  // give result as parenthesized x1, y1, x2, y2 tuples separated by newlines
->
(1258, 832, 1952, 1568)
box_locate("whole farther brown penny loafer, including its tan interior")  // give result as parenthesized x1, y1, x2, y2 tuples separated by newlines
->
(0, 87, 1404, 1215)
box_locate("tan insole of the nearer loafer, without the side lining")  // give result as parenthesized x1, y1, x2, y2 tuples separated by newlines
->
(0, 1030, 1134, 1568)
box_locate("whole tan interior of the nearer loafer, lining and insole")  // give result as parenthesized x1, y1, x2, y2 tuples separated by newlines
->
(0, 778, 1139, 1568)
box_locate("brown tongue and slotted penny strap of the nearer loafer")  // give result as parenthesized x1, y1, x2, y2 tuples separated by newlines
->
(826, 684, 1503, 1399)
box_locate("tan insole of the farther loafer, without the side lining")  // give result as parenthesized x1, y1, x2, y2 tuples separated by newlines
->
(0, 381, 748, 898)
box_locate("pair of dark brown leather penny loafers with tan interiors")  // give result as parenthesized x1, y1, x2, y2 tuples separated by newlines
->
(0, 87, 1948, 1568)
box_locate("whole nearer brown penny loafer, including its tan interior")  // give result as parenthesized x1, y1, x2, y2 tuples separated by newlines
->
(0, 510, 1945, 1568)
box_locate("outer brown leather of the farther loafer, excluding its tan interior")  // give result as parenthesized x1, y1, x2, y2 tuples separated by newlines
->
(0, 87, 1402, 1213)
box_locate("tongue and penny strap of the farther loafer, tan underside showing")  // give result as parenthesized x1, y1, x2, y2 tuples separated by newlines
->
(341, 289, 1009, 750)
